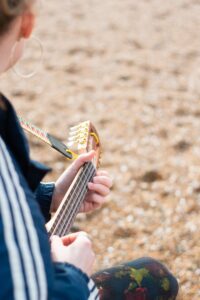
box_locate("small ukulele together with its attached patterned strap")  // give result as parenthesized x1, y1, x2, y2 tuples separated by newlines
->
(18, 117, 101, 236)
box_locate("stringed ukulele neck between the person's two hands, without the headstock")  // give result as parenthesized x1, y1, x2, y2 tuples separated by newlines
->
(49, 162, 96, 236)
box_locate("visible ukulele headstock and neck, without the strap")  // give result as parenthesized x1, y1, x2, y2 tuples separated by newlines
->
(44, 121, 101, 236)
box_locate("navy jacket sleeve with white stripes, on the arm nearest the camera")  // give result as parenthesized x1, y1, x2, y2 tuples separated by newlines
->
(0, 138, 98, 300)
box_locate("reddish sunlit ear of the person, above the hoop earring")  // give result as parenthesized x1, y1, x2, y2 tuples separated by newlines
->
(21, 12, 35, 39)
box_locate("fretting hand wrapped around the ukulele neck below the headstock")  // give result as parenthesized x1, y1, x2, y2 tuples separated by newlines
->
(51, 151, 112, 212)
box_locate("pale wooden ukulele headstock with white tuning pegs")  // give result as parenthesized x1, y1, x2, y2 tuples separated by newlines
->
(67, 121, 101, 168)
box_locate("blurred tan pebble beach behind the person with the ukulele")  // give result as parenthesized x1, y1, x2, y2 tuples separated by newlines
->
(0, 0, 200, 300)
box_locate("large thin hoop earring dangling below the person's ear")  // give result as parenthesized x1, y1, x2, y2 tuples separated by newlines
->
(10, 36, 43, 78)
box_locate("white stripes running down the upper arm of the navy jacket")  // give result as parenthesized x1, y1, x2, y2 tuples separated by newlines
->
(0, 139, 47, 300)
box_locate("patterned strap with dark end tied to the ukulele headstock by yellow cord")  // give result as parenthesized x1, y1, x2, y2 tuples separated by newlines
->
(18, 117, 77, 160)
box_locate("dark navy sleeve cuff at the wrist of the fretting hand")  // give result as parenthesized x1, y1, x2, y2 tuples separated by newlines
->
(35, 182, 55, 222)
